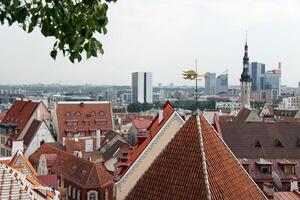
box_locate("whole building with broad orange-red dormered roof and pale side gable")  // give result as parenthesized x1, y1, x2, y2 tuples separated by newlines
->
(52, 101, 113, 144)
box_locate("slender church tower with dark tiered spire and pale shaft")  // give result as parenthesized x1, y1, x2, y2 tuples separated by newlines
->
(240, 39, 252, 108)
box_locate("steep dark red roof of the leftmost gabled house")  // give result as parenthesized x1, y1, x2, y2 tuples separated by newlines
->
(2, 99, 40, 133)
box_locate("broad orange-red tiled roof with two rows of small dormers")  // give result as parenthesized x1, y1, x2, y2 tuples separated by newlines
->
(56, 102, 113, 143)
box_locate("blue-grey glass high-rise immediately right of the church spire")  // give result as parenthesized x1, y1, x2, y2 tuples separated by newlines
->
(249, 62, 266, 91)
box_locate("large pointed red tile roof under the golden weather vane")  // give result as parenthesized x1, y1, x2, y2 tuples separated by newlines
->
(126, 116, 266, 200)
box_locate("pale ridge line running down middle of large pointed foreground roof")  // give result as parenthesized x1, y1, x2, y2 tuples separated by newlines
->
(196, 114, 211, 200)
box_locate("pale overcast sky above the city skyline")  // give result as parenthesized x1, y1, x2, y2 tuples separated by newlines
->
(0, 0, 300, 87)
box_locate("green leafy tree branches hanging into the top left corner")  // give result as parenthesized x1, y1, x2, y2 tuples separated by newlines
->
(0, 0, 116, 63)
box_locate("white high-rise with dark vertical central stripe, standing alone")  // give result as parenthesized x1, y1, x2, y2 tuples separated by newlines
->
(131, 72, 153, 103)
